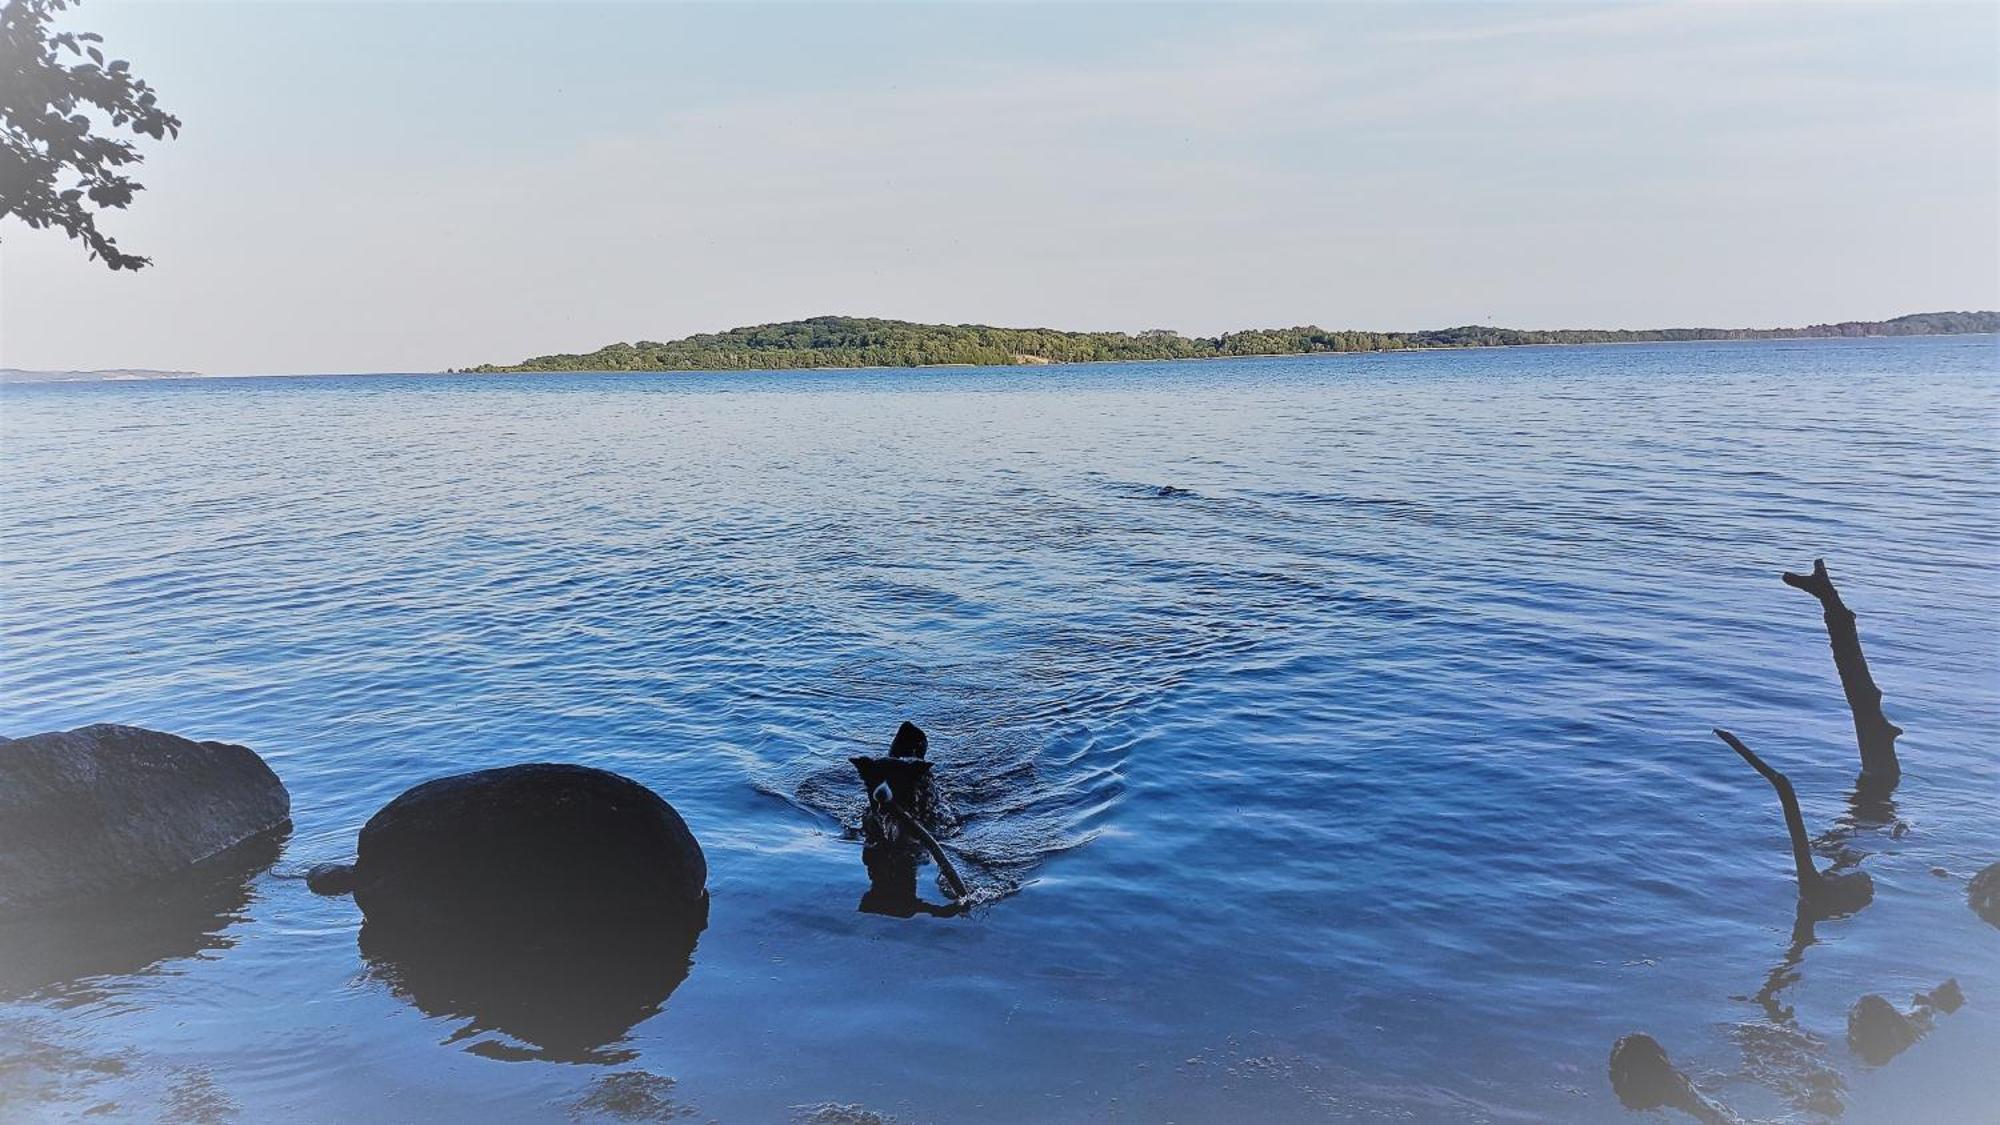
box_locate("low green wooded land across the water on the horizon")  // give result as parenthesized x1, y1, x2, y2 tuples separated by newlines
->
(454, 312, 2000, 374)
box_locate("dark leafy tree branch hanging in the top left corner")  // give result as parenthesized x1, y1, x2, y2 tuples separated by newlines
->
(0, 0, 180, 270)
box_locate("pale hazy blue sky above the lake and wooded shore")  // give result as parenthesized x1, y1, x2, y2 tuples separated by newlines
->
(0, 0, 2000, 372)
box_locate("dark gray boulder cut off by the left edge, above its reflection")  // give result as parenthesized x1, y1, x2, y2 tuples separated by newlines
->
(0, 723, 292, 904)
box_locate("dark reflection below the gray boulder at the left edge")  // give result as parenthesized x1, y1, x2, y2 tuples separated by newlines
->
(0, 833, 288, 1003)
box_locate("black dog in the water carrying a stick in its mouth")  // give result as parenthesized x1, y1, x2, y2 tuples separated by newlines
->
(848, 723, 970, 917)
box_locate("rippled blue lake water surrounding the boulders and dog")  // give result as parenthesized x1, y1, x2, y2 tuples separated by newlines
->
(0, 336, 2000, 1121)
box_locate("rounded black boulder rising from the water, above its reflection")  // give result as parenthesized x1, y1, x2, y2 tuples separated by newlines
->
(352, 765, 708, 941)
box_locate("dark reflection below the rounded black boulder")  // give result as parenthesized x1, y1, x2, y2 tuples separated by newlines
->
(360, 904, 700, 1063)
